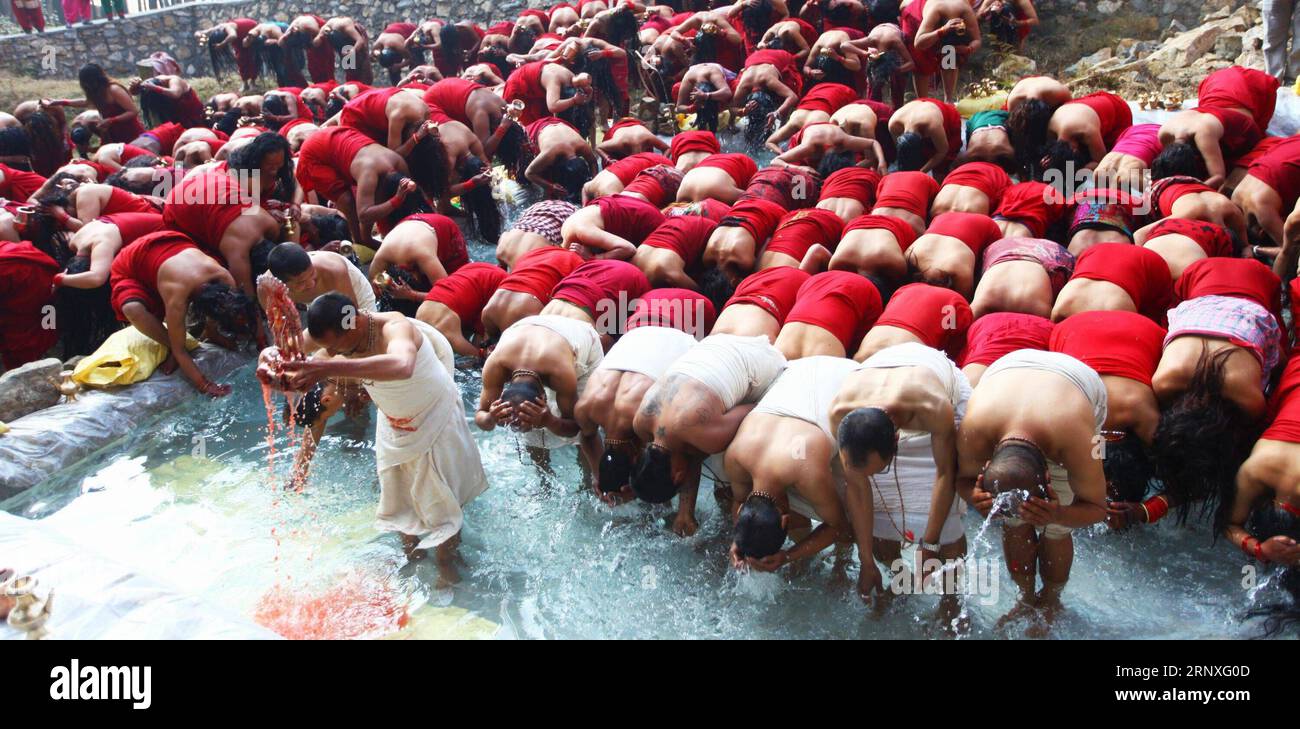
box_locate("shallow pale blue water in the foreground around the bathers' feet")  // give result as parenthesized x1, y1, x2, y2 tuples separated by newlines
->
(0, 106, 1294, 638)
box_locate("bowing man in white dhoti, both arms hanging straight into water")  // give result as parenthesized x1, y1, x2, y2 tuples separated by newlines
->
(831, 342, 971, 615)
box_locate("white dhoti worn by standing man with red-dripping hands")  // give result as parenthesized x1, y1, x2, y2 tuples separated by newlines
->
(363, 328, 488, 548)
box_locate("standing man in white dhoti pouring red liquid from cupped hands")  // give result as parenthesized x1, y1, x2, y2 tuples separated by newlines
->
(257, 294, 488, 582)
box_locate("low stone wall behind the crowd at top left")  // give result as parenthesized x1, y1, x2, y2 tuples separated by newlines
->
(0, 0, 540, 78)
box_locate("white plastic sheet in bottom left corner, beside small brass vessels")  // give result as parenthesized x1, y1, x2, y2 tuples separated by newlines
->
(0, 512, 278, 639)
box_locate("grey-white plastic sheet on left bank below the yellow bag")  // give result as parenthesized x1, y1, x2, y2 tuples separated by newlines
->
(0, 346, 248, 502)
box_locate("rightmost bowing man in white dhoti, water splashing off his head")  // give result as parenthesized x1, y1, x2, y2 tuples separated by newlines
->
(957, 350, 1106, 630)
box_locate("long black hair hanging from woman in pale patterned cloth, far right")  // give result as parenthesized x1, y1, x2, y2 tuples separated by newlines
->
(1153, 348, 1260, 538)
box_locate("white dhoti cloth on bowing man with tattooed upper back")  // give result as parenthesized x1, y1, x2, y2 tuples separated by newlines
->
(664, 334, 785, 411)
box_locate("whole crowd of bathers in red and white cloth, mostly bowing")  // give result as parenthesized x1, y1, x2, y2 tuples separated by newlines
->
(0, 0, 1300, 632)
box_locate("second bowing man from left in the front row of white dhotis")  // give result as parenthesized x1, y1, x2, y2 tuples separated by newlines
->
(575, 326, 698, 517)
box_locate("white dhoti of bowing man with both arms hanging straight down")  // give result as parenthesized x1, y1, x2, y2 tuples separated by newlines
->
(858, 342, 971, 544)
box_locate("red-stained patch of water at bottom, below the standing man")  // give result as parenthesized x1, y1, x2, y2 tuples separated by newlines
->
(254, 574, 410, 641)
